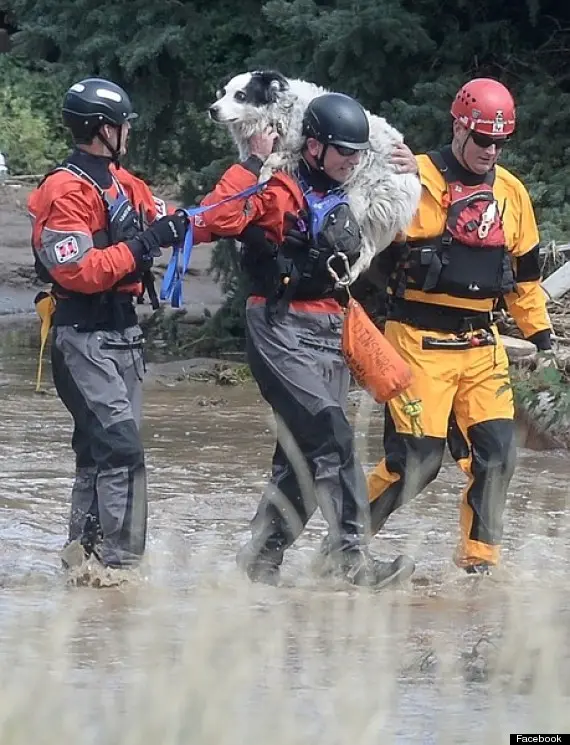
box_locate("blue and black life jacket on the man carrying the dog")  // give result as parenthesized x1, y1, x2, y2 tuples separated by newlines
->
(260, 179, 362, 317)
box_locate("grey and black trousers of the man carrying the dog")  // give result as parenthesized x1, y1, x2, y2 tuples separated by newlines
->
(246, 302, 369, 562)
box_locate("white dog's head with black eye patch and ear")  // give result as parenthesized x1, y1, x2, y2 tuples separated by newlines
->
(208, 70, 289, 124)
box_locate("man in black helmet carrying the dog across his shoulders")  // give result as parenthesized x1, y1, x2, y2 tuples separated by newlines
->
(203, 88, 415, 586)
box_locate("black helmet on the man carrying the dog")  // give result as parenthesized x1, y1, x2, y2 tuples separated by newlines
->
(303, 93, 370, 150)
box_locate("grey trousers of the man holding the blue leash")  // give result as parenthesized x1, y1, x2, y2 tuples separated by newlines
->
(52, 326, 147, 566)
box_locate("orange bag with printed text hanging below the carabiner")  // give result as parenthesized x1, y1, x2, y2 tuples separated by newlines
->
(342, 297, 412, 403)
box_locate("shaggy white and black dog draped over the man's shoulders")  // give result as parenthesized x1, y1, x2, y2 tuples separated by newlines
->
(209, 70, 421, 281)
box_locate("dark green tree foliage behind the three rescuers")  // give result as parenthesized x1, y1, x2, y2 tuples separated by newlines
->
(0, 0, 570, 354)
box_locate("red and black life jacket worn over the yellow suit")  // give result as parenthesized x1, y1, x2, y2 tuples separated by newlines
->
(395, 152, 515, 299)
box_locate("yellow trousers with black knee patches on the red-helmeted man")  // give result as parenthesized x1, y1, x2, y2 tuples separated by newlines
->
(368, 321, 516, 567)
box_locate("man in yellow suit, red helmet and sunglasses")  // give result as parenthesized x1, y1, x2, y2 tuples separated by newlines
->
(362, 78, 551, 574)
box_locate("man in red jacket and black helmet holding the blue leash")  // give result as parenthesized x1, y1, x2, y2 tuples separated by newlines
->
(28, 78, 205, 567)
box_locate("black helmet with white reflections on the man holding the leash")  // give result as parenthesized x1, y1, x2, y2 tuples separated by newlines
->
(62, 78, 137, 144)
